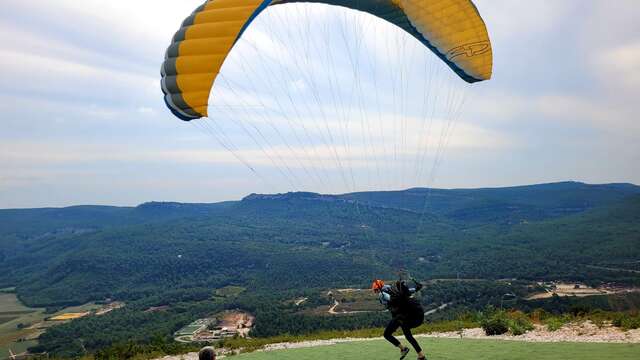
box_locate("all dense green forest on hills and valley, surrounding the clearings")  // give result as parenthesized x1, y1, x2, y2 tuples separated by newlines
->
(0, 183, 640, 355)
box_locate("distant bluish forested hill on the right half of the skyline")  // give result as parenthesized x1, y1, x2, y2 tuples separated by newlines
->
(341, 182, 640, 223)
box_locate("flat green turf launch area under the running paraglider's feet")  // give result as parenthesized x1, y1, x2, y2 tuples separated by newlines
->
(234, 338, 640, 360)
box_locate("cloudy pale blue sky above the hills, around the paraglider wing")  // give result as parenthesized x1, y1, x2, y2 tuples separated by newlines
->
(0, 0, 640, 208)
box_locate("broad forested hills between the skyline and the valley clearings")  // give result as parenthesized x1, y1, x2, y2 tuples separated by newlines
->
(0, 183, 640, 305)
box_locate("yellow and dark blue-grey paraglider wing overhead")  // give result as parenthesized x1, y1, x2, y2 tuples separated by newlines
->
(161, 0, 493, 121)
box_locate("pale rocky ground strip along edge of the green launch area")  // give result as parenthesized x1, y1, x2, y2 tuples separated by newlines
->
(157, 321, 640, 360)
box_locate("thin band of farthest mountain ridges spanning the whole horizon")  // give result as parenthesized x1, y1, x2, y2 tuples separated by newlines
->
(0, 182, 640, 234)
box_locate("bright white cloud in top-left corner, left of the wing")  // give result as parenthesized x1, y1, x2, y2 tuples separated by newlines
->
(3, 0, 202, 55)
